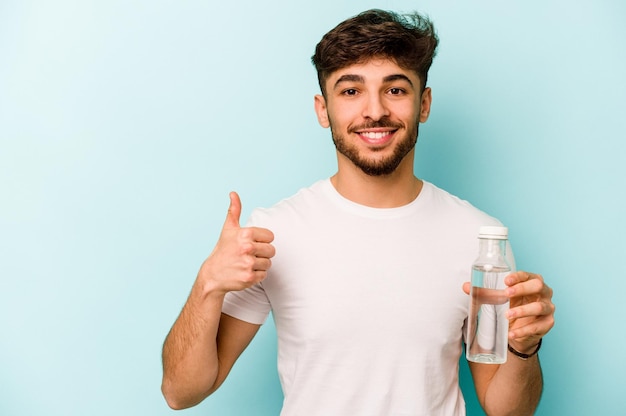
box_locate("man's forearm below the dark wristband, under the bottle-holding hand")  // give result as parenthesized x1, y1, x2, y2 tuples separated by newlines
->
(482, 353, 543, 416)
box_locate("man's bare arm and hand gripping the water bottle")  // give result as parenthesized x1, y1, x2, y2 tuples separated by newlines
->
(466, 272, 555, 416)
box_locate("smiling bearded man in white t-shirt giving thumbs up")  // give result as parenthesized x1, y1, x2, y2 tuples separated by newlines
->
(162, 10, 554, 416)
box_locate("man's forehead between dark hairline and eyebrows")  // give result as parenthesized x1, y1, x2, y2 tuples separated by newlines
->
(326, 58, 420, 89)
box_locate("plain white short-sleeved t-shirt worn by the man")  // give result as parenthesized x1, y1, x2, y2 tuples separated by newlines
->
(223, 179, 500, 416)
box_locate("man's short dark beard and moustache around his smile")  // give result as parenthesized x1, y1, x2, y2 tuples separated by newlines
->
(330, 119, 419, 176)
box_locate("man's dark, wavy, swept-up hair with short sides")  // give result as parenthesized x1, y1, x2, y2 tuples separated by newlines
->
(311, 9, 439, 95)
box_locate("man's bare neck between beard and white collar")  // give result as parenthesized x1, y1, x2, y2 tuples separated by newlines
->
(330, 150, 423, 208)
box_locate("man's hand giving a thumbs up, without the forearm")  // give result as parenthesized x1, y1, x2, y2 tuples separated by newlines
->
(197, 192, 276, 294)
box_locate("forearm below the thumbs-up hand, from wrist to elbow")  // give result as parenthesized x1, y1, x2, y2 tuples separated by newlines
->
(161, 287, 223, 409)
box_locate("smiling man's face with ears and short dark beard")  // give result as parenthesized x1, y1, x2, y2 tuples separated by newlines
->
(315, 59, 431, 176)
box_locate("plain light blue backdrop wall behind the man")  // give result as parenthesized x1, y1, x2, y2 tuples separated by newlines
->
(0, 0, 626, 416)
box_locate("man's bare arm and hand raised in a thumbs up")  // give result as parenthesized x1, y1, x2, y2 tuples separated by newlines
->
(161, 193, 275, 409)
